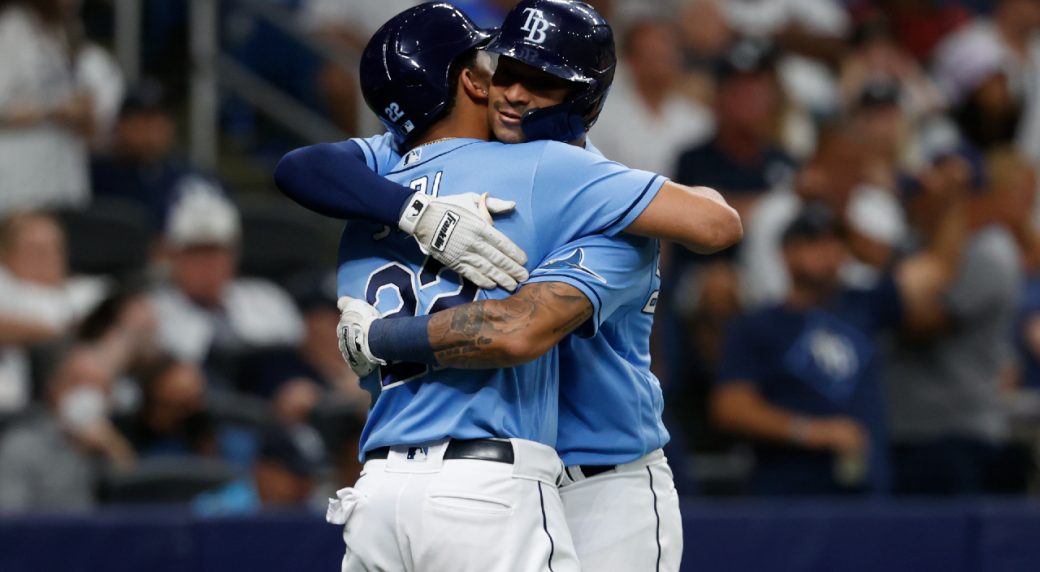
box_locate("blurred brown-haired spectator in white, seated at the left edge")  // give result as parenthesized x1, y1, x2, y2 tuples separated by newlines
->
(0, 213, 106, 412)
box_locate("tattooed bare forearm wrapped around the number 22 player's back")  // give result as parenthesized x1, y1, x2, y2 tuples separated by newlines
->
(427, 282, 593, 368)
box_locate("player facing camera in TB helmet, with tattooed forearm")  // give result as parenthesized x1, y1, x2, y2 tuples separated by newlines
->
(332, 1, 682, 571)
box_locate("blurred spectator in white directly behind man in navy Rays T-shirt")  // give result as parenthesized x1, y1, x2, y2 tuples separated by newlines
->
(739, 124, 906, 307)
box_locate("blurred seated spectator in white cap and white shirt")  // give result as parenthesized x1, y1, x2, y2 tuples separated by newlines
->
(154, 189, 304, 385)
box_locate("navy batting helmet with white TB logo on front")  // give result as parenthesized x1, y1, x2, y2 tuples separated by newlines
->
(488, 0, 618, 141)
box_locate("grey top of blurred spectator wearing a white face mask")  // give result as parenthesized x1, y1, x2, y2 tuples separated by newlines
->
(0, 413, 95, 513)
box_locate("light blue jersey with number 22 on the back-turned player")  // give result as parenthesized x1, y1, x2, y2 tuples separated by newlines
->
(338, 139, 665, 451)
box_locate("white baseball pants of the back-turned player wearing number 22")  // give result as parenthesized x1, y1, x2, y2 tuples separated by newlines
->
(327, 439, 580, 572)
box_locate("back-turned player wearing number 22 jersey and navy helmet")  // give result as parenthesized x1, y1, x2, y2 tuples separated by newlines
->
(307, 4, 740, 570)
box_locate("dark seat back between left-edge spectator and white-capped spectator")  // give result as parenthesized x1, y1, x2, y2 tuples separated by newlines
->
(57, 200, 151, 277)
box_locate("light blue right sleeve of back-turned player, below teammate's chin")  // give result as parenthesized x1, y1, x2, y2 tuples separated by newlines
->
(531, 141, 668, 237)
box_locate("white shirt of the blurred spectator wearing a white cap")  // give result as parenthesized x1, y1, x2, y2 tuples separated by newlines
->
(153, 279, 304, 363)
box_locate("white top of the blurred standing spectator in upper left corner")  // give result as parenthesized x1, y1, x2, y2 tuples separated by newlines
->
(0, 5, 89, 214)
